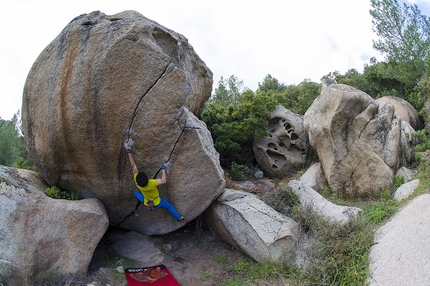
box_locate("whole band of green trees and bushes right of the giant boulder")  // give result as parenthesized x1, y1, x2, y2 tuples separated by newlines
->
(200, 0, 430, 174)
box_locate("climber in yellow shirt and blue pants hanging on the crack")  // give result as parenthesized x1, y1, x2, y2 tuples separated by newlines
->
(124, 141, 184, 221)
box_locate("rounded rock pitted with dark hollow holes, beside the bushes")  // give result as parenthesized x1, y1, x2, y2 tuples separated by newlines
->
(253, 106, 310, 177)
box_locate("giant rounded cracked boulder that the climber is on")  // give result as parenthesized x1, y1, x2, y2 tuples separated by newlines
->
(22, 11, 224, 235)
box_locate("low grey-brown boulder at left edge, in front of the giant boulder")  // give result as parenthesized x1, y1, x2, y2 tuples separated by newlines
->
(0, 166, 109, 285)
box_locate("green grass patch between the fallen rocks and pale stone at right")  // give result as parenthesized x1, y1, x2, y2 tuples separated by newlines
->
(215, 166, 430, 286)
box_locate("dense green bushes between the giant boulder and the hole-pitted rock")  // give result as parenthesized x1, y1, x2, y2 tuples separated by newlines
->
(200, 77, 321, 169)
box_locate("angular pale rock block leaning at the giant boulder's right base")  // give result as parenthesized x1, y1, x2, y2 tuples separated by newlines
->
(203, 189, 298, 265)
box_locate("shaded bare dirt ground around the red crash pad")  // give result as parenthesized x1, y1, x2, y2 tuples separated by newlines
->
(88, 220, 244, 286)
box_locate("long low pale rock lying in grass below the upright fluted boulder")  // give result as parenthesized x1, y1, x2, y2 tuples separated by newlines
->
(288, 180, 362, 224)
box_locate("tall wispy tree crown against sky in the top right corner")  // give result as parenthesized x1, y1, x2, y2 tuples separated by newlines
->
(370, 0, 430, 62)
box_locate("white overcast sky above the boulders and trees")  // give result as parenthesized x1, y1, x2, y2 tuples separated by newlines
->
(0, 0, 430, 120)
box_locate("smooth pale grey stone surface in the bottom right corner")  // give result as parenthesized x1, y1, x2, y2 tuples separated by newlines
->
(369, 194, 430, 286)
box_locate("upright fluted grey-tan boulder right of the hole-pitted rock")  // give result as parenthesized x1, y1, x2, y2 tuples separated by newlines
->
(304, 84, 414, 196)
